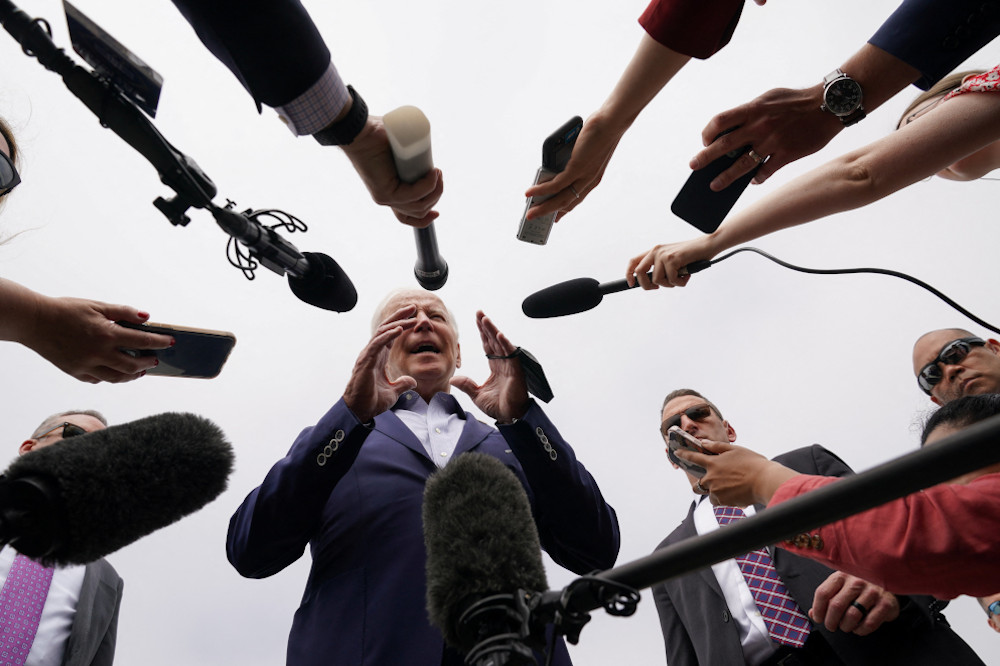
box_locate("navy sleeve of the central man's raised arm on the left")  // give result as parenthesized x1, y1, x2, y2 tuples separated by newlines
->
(226, 400, 371, 578)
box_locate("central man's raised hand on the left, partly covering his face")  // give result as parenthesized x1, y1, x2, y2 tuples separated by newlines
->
(344, 305, 417, 423)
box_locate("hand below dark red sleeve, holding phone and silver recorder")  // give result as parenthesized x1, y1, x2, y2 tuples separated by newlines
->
(524, 113, 625, 221)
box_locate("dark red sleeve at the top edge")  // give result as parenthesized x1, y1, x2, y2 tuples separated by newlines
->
(639, 0, 743, 59)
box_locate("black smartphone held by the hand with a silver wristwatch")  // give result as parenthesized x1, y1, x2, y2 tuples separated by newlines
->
(670, 127, 760, 234)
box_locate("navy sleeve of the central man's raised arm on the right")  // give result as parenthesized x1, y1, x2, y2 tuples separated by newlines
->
(499, 401, 620, 574)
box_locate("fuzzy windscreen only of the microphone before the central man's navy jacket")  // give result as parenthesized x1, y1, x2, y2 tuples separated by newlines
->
(423, 453, 548, 649)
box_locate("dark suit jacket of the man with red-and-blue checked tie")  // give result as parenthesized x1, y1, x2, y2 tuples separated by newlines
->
(653, 445, 983, 666)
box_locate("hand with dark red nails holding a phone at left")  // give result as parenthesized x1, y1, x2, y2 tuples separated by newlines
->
(18, 294, 174, 384)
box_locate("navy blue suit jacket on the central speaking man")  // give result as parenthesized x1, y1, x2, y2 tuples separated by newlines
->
(227, 400, 619, 666)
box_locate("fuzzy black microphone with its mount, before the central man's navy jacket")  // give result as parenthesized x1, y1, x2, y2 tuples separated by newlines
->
(423, 453, 548, 664)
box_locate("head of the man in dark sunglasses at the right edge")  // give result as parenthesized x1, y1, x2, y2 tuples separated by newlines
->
(913, 328, 1000, 405)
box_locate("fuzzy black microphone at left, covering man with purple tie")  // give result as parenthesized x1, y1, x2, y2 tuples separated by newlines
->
(0, 413, 233, 566)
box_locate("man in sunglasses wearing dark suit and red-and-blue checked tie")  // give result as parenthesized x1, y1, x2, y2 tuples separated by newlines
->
(653, 389, 982, 666)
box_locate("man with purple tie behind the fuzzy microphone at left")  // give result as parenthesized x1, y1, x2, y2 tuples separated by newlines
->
(0, 410, 124, 666)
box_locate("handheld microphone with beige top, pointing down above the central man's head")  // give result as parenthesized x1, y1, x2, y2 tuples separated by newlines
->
(382, 106, 448, 291)
